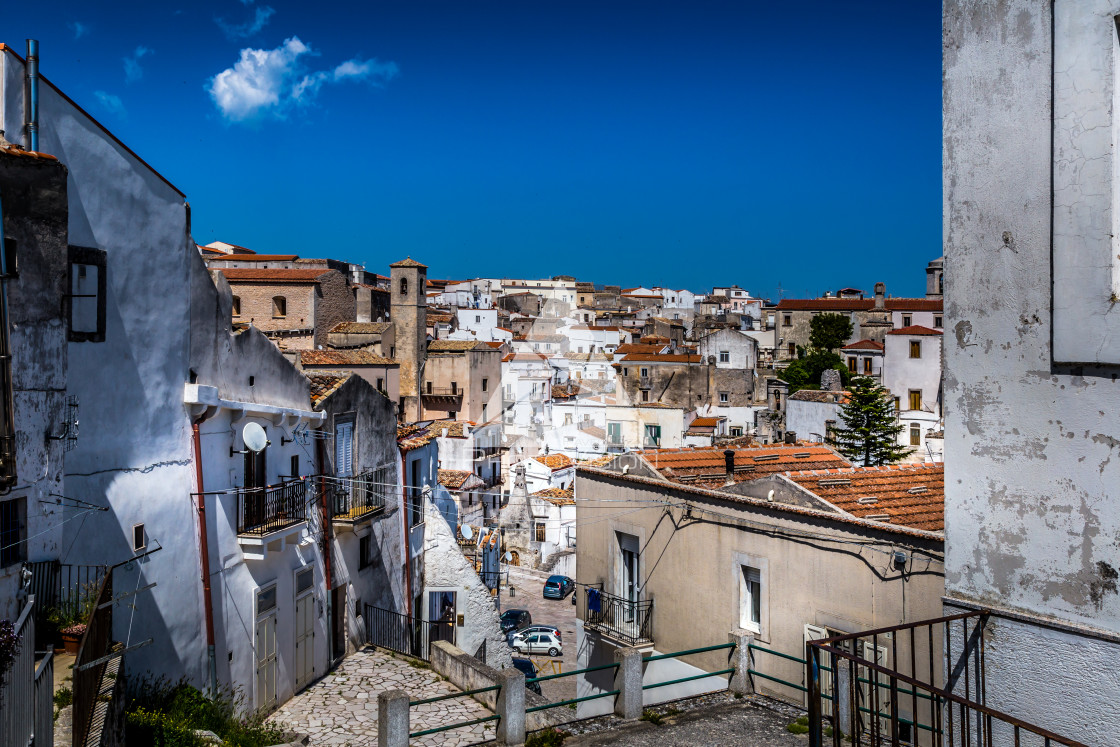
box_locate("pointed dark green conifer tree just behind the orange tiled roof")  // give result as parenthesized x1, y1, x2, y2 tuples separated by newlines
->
(828, 376, 912, 467)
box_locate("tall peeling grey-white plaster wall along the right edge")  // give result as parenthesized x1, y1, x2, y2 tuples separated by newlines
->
(943, 0, 1120, 744)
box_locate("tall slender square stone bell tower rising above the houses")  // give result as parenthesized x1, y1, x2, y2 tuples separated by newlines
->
(389, 258, 428, 422)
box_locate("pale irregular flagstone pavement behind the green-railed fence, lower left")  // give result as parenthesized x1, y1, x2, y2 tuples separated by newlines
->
(269, 647, 494, 747)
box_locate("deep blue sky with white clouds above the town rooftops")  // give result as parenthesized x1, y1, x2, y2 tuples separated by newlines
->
(8, 0, 941, 298)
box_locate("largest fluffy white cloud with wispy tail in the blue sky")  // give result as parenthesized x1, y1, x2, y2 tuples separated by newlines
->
(207, 37, 399, 122)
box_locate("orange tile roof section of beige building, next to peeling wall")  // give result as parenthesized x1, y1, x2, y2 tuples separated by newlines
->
(786, 464, 945, 532)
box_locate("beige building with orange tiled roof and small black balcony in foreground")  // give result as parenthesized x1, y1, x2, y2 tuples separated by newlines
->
(576, 445, 944, 730)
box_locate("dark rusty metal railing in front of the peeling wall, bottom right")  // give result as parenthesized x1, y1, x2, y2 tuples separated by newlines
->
(805, 610, 1085, 747)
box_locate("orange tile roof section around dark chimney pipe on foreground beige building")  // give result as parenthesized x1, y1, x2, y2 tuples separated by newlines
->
(642, 443, 851, 489)
